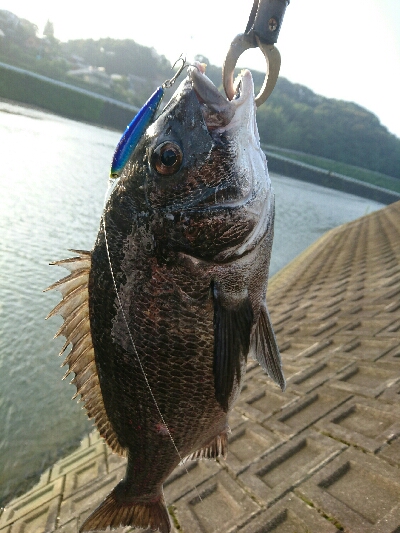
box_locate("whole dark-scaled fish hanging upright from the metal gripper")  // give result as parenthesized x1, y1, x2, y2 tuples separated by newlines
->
(49, 63, 285, 533)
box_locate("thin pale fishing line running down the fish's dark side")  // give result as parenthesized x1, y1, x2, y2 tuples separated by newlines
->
(101, 180, 203, 502)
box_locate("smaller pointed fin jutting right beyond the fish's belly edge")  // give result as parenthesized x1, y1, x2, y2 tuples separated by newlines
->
(251, 306, 286, 391)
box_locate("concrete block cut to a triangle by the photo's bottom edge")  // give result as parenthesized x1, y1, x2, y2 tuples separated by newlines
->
(238, 492, 338, 533)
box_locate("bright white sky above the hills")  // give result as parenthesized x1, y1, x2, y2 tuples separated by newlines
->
(0, 0, 400, 137)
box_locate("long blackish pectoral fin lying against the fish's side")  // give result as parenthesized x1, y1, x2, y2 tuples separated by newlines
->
(212, 284, 253, 411)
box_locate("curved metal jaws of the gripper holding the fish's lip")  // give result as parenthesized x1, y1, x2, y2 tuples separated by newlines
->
(222, 33, 281, 107)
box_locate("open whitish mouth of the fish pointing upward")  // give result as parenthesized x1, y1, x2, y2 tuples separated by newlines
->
(188, 62, 255, 131)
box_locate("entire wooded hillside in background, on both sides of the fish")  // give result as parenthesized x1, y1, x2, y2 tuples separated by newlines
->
(0, 10, 400, 178)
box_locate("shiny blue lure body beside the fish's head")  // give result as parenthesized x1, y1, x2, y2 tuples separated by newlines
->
(110, 86, 164, 179)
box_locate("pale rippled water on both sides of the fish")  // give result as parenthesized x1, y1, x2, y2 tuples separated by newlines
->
(0, 102, 381, 503)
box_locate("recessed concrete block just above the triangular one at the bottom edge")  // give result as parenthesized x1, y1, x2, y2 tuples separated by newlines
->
(239, 430, 346, 507)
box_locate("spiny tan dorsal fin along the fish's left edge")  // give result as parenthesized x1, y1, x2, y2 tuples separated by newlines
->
(46, 250, 126, 456)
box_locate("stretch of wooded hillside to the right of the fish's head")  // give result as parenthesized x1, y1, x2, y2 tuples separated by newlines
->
(258, 78, 400, 178)
